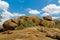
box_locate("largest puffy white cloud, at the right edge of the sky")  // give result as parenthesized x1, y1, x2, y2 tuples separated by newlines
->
(42, 4, 60, 19)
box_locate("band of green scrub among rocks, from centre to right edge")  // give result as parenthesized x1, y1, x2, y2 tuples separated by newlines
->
(16, 17, 60, 30)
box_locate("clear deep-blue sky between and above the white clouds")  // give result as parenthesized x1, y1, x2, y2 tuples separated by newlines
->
(3, 0, 60, 17)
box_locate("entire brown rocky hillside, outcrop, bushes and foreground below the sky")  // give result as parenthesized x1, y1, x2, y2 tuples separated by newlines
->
(0, 16, 60, 40)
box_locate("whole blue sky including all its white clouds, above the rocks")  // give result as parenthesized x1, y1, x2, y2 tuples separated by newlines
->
(0, 0, 60, 22)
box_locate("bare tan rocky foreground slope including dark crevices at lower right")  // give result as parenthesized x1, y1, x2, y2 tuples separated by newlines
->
(0, 26, 60, 40)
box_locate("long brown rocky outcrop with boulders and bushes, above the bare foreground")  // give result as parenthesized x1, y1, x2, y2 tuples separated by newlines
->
(3, 16, 54, 30)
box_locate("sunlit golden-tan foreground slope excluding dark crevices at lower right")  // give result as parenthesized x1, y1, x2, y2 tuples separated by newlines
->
(0, 26, 59, 40)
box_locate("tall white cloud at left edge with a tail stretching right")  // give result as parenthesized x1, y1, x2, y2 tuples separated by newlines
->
(0, 0, 25, 25)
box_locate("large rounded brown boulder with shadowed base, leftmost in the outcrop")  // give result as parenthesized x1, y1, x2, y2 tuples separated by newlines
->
(3, 20, 18, 30)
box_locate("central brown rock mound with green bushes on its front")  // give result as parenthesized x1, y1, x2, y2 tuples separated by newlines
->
(18, 16, 41, 27)
